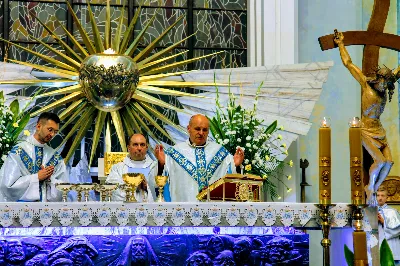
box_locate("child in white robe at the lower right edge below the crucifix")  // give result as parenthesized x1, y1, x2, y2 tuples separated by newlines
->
(376, 187, 400, 265)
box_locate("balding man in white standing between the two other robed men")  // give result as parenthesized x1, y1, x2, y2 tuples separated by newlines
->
(106, 134, 158, 202)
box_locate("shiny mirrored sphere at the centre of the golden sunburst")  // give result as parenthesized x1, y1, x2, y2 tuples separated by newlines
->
(79, 54, 139, 112)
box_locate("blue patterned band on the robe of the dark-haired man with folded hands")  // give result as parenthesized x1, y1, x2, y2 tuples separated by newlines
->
(10, 146, 62, 201)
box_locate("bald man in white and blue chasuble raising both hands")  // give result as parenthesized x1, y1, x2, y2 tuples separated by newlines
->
(155, 114, 244, 202)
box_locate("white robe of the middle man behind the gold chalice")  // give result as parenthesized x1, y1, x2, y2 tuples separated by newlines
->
(106, 155, 158, 202)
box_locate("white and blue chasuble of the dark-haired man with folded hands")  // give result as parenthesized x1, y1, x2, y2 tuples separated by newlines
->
(0, 136, 69, 202)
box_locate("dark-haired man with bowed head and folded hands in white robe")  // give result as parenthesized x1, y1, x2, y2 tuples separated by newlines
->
(0, 112, 69, 202)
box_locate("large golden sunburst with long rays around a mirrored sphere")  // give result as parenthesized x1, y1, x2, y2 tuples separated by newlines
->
(0, 0, 225, 165)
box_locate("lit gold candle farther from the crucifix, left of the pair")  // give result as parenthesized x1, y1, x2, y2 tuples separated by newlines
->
(319, 117, 331, 204)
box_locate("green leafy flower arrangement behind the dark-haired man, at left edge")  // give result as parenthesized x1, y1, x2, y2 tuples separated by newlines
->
(0, 91, 34, 167)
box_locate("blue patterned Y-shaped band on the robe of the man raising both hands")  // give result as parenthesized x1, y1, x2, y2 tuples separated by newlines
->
(165, 147, 229, 191)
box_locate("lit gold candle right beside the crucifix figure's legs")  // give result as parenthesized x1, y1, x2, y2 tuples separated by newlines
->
(349, 117, 365, 205)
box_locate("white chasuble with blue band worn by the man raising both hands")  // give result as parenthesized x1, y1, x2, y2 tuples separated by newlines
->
(164, 140, 236, 202)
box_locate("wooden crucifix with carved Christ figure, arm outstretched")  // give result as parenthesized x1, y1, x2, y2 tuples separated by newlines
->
(318, 0, 400, 204)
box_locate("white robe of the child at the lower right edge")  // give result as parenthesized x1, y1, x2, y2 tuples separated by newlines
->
(378, 204, 400, 260)
